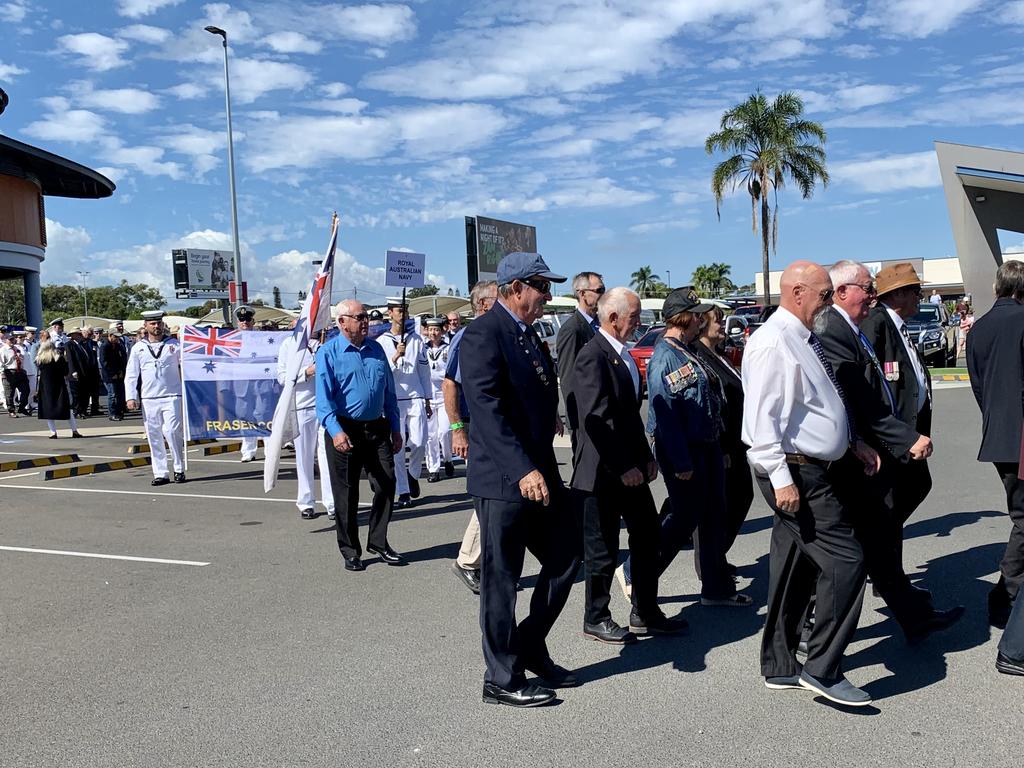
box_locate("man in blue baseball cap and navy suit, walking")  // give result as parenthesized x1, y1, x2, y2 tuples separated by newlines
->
(460, 253, 580, 707)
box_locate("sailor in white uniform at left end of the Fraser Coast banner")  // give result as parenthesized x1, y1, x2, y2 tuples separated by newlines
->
(125, 309, 185, 485)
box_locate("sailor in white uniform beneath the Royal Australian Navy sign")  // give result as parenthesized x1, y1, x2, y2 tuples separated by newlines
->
(377, 298, 433, 509)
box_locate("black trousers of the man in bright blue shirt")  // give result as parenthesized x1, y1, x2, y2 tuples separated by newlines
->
(324, 419, 394, 557)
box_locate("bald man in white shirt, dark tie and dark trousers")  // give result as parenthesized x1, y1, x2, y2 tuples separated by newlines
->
(742, 261, 880, 707)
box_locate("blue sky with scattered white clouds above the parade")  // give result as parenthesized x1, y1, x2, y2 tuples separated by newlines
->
(0, 0, 1024, 304)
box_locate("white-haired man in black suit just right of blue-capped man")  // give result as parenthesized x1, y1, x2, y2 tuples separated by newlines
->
(571, 288, 686, 645)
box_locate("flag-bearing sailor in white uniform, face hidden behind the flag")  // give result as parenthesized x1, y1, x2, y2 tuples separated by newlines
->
(278, 336, 335, 520)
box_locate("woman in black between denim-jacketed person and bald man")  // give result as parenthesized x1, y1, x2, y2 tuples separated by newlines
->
(690, 307, 754, 575)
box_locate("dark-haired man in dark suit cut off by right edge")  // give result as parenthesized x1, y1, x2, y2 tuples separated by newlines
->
(967, 261, 1024, 627)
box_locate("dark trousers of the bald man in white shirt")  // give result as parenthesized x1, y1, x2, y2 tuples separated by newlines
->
(756, 464, 864, 681)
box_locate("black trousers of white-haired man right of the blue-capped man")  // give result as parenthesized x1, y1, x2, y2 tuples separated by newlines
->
(578, 477, 660, 624)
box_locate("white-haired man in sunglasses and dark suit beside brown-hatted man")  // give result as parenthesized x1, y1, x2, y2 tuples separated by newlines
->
(818, 261, 964, 643)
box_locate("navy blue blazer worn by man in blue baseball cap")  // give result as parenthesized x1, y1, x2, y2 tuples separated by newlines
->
(459, 304, 562, 502)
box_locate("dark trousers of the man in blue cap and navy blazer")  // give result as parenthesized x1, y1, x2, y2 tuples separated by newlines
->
(476, 493, 580, 690)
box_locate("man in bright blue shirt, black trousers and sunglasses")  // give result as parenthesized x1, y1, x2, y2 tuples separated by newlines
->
(316, 299, 406, 570)
